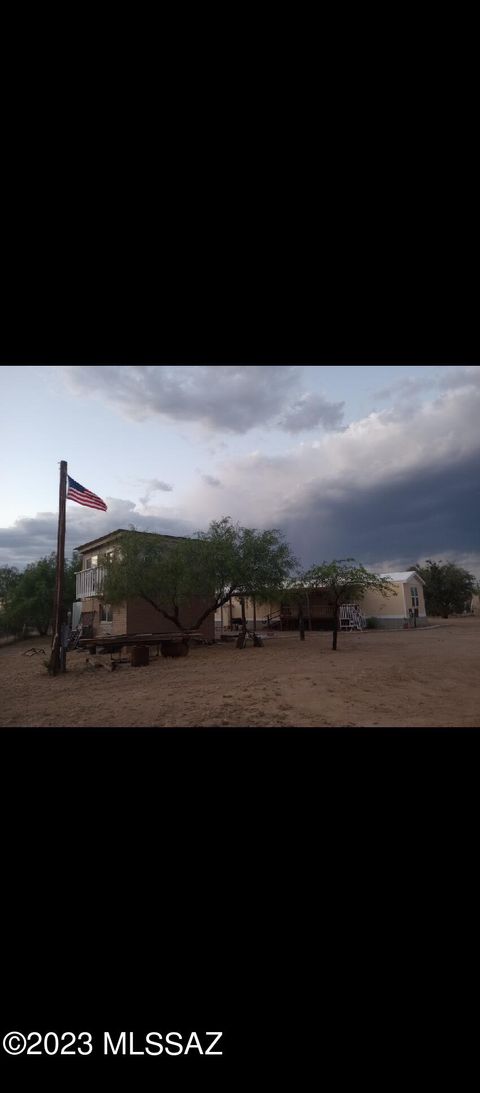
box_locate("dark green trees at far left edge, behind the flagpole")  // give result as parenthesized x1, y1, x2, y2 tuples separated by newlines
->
(2, 552, 79, 635)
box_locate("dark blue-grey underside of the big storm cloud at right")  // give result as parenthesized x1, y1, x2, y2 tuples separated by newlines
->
(281, 454, 480, 566)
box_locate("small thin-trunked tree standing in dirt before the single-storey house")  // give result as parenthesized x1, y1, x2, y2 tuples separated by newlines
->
(303, 557, 395, 649)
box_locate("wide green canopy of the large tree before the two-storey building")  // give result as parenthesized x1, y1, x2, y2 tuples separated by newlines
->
(101, 517, 299, 630)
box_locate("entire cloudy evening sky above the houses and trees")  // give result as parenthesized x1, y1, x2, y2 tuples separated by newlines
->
(0, 364, 480, 577)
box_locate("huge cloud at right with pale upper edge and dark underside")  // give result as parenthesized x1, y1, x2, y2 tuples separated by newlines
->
(177, 374, 480, 572)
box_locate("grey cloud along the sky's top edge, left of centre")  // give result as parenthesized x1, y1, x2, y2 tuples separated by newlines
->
(58, 364, 302, 433)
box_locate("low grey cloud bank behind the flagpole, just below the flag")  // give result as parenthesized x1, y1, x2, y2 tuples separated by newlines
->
(0, 497, 197, 569)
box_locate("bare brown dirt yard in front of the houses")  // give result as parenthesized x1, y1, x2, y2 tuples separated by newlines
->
(0, 616, 480, 728)
